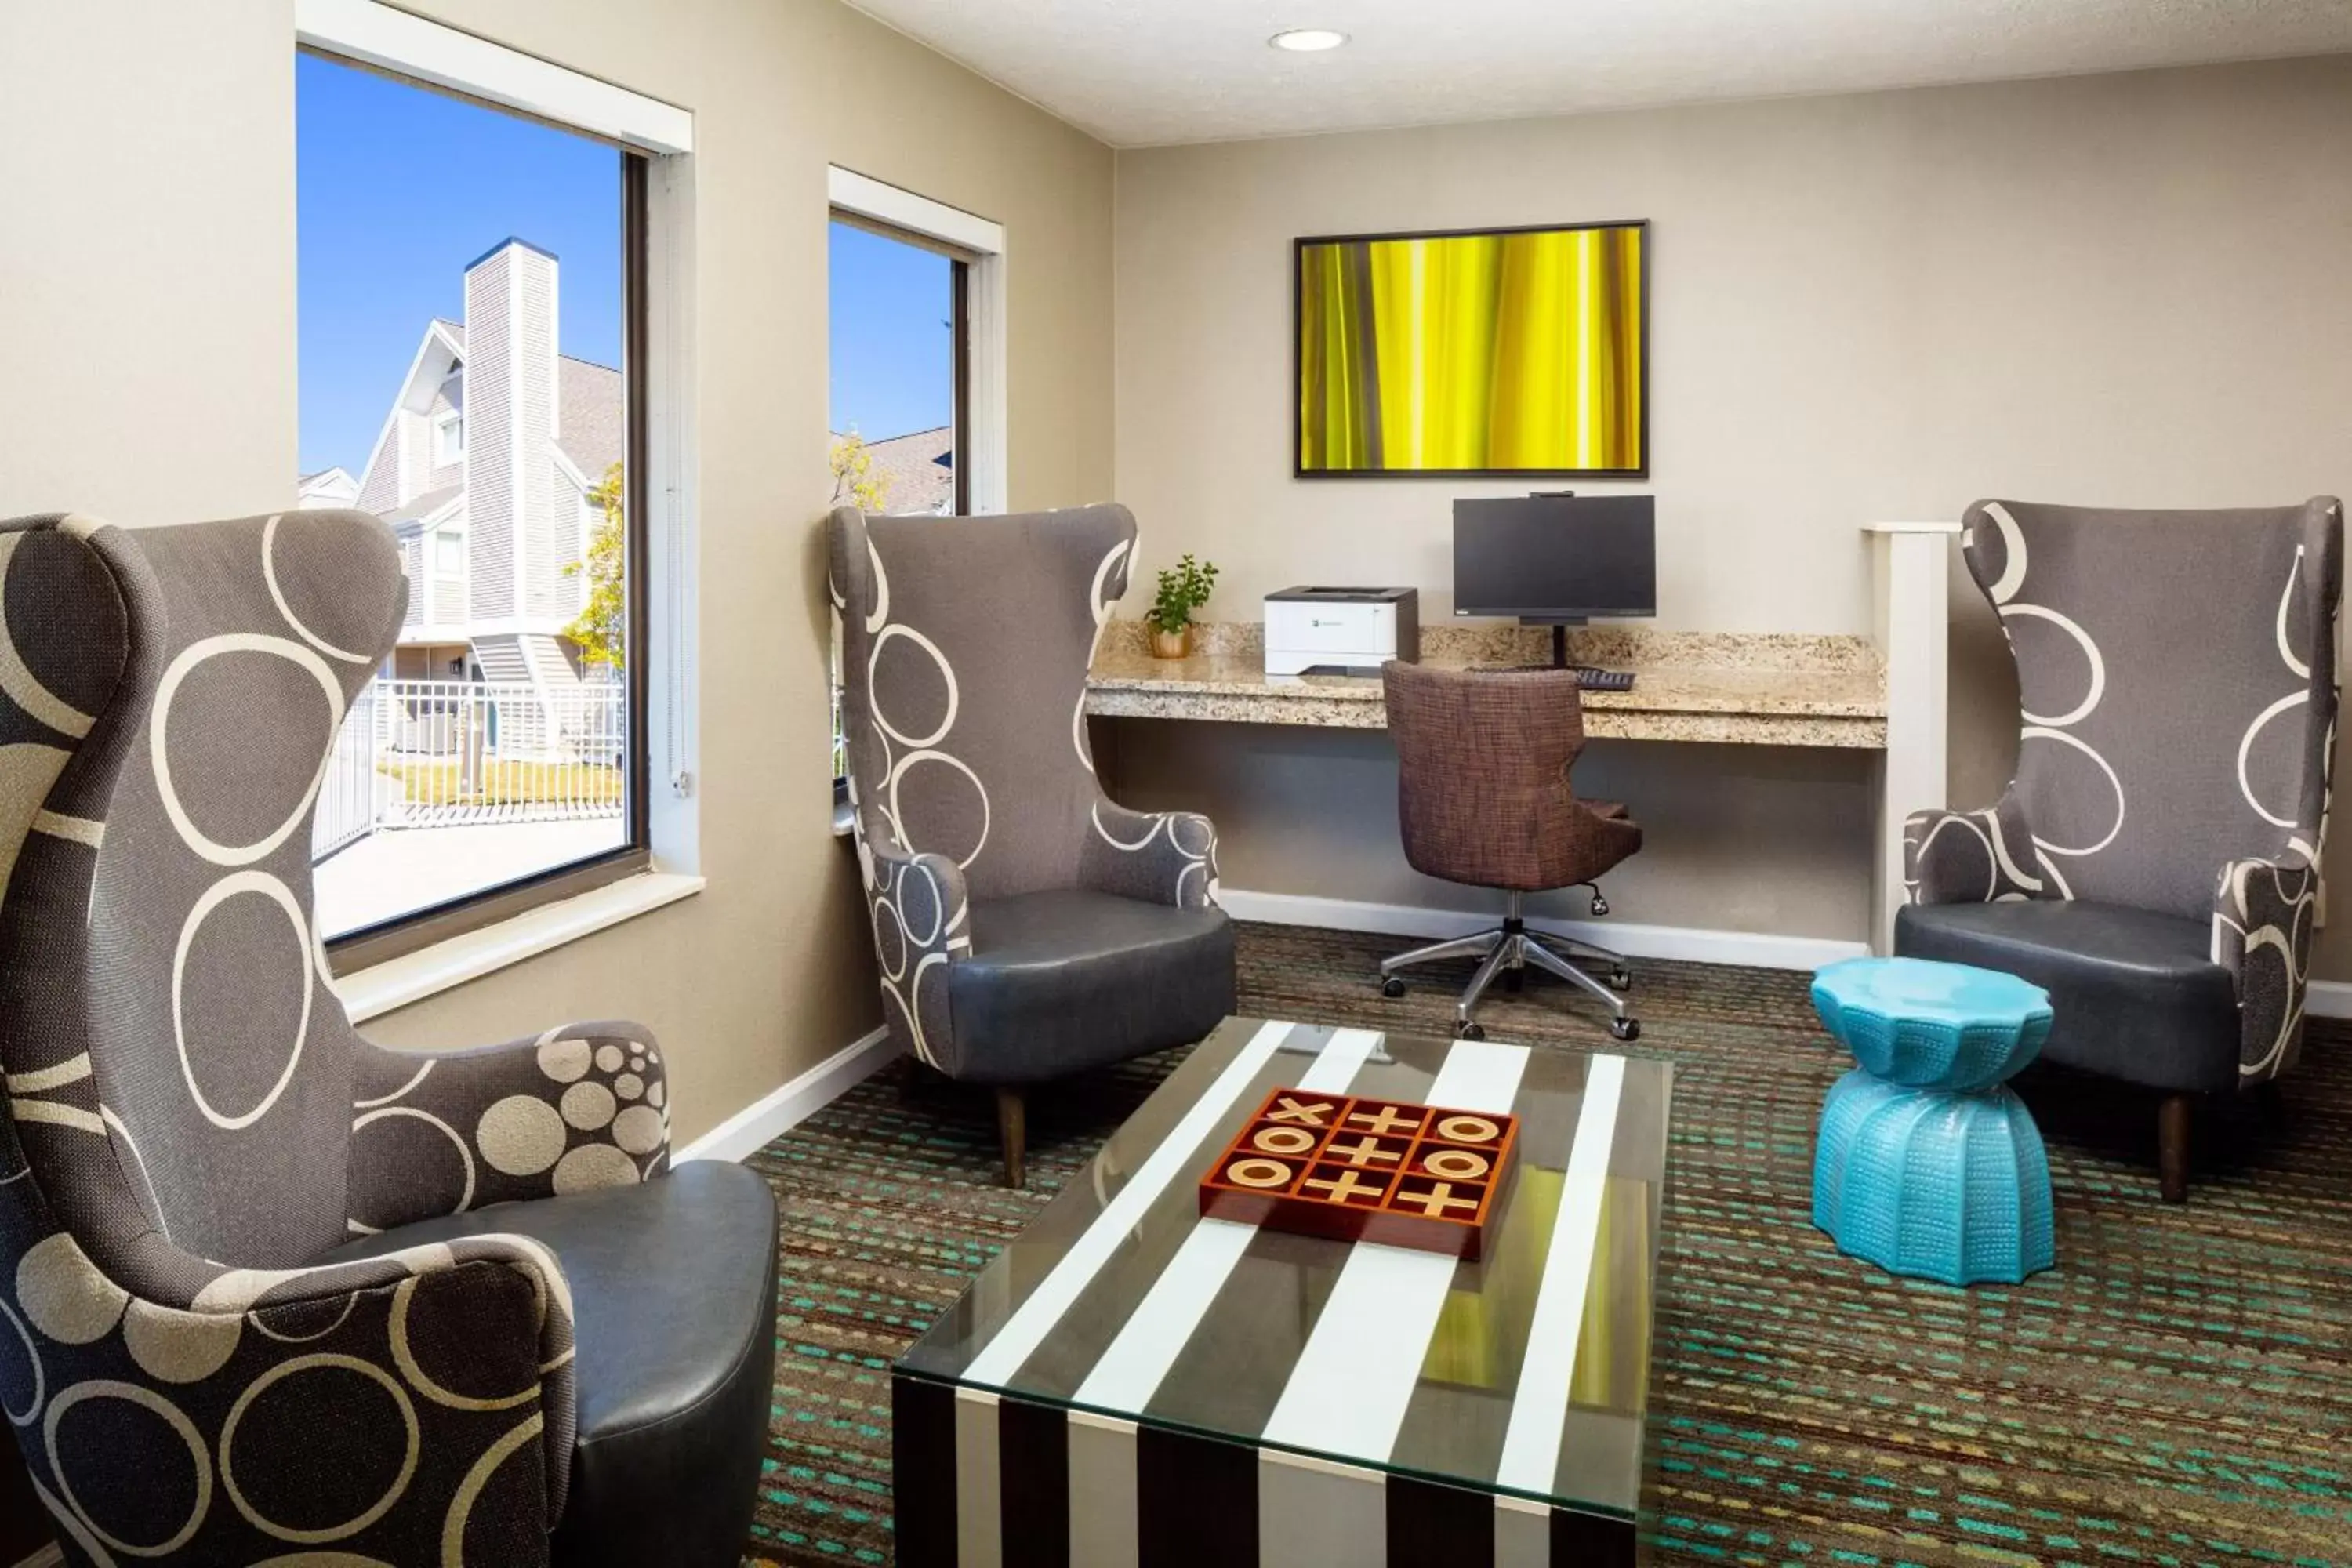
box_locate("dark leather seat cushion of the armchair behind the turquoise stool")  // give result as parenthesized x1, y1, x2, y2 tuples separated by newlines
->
(1896, 898, 2239, 1091)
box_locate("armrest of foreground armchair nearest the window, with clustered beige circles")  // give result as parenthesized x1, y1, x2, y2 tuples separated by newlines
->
(350, 1020, 670, 1234)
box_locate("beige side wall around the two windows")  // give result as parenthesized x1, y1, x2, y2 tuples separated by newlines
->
(0, 0, 1112, 1140)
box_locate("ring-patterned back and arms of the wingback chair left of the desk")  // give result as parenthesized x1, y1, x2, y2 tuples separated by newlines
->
(828, 506, 1216, 1081)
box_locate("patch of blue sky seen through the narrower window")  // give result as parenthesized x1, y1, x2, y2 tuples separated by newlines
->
(830, 223, 955, 442)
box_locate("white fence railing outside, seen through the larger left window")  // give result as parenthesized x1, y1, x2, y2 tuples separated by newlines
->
(310, 677, 628, 860)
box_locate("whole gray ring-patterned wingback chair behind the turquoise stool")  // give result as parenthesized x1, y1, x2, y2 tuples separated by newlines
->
(1896, 496, 2343, 1201)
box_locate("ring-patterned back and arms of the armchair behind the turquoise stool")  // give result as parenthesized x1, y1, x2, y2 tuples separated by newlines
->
(1903, 496, 2343, 1083)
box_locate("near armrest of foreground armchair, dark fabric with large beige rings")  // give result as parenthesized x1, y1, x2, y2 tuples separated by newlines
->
(0, 1203, 576, 1563)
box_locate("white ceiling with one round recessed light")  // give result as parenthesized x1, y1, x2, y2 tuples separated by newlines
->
(851, 0, 2352, 146)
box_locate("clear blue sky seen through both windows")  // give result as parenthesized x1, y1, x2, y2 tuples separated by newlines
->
(294, 54, 955, 477)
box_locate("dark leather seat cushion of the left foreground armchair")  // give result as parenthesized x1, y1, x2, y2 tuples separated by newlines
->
(327, 1161, 776, 1568)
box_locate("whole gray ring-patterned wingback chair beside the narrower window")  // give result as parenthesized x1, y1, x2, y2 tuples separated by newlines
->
(828, 506, 1232, 1187)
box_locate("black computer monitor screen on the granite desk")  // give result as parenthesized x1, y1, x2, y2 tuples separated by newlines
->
(1454, 496, 1658, 621)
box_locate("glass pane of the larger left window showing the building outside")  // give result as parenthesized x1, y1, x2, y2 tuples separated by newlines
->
(296, 54, 633, 938)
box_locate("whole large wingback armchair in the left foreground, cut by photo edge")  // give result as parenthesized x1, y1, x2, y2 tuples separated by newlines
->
(0, 513, 776, 1568)
